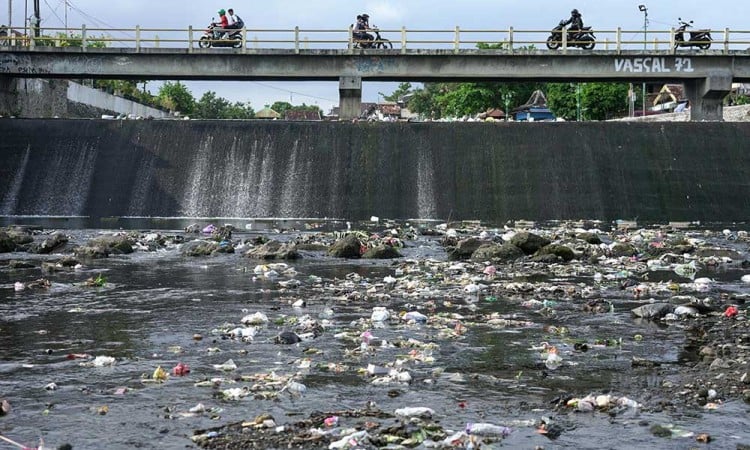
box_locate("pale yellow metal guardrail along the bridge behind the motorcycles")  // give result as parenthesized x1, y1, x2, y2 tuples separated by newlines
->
(0, 25, 750, 53)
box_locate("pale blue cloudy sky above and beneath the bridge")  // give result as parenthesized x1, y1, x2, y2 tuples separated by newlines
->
(0, 0, 750, 112)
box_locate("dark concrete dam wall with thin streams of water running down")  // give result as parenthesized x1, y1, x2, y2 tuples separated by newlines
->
(0, 119, 750, 223)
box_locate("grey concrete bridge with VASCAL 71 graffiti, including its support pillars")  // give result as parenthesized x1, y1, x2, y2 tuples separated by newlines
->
(0, 46, 750, 120)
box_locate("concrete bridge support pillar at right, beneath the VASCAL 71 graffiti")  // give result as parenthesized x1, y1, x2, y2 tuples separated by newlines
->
(685, 73, 732, 121)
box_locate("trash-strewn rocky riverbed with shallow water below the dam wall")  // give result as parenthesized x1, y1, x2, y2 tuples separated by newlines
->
(0, 222, 750, 448)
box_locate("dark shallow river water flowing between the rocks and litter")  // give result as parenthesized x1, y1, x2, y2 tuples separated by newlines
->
(0, 222, 750, 449)
